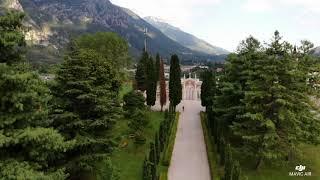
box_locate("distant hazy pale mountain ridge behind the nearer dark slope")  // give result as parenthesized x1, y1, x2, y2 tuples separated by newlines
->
(144, 16, 229, 55)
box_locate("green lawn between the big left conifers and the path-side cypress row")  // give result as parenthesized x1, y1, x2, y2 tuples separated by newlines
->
(111, 112, 164, 180)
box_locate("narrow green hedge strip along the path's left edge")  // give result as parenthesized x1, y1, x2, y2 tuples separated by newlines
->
(159, 113, 180, 180)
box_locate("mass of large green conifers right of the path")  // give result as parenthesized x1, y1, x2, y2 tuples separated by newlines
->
(208, 32, 320, 178)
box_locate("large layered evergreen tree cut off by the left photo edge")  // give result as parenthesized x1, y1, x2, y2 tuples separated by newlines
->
(0, 12, 73, 180)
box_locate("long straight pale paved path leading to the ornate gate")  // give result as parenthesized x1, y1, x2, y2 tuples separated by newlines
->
(168, 101, 211, 180)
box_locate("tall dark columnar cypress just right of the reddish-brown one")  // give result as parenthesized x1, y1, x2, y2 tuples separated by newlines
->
(169, 55, 182, 109)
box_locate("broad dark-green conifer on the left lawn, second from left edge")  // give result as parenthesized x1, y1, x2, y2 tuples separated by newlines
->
(51, 43, 121, 178)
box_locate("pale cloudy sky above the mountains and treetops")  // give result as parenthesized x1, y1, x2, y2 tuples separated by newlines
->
(111, 0, 320, 51)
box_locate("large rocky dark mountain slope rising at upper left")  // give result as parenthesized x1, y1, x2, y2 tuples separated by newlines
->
(0, 0, 223, 64)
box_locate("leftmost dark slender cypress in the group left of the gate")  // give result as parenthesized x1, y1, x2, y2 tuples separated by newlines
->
(135, 52, 149, 91)
